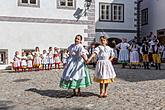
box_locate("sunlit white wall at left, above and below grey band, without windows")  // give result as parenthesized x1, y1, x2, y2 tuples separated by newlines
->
(0, 0, 88, 68)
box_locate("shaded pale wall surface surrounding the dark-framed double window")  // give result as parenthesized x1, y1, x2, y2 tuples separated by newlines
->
(95, 0, 137, 40)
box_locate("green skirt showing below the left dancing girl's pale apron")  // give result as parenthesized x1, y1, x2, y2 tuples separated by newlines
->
(60, 68, 92, 89)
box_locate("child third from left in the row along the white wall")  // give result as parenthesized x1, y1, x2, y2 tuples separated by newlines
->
(27, 52, 33, 71)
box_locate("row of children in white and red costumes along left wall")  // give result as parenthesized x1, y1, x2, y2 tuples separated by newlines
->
(12, 47, 68, 71)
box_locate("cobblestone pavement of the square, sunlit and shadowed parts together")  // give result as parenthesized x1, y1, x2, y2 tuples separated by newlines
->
(0, 64, 165, 110)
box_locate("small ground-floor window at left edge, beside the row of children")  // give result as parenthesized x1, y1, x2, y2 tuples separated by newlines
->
(0, 49, 8, 64)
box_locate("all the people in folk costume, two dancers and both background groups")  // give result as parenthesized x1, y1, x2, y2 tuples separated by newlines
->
(13, 33, 165, 98)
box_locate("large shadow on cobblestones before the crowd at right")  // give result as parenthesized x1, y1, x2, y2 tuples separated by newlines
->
(115, 67, 165, 82)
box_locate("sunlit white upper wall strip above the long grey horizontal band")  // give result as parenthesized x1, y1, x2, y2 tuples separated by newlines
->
(0, 0, 87, 20)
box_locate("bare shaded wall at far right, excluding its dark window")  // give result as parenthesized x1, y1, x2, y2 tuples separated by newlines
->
(141, 0, 165, 36)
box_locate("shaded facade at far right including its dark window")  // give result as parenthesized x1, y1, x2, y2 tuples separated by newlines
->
(140, 0, 165, 43)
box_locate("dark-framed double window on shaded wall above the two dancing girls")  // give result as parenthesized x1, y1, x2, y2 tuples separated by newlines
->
(99, 3, 124, 22)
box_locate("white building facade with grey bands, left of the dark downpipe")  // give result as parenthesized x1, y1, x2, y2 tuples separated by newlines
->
(0, 0, 137, 68)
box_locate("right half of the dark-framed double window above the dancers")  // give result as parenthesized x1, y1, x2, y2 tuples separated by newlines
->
(112, 4, 124, 22)
